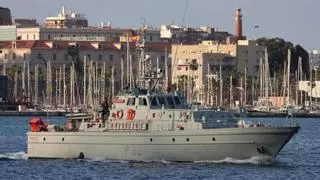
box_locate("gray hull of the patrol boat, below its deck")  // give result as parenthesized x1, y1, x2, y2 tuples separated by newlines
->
(28, 127, 299, 161)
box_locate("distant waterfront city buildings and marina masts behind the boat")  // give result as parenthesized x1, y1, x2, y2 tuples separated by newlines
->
(0, 7, 320, 110)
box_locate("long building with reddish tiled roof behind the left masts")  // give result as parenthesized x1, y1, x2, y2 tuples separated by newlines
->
(0, 40, 171, 100)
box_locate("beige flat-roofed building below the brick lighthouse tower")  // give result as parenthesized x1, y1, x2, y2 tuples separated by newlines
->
(172, 40, 265, 101)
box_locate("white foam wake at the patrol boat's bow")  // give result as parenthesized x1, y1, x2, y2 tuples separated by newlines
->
(195, 156, 274, 164)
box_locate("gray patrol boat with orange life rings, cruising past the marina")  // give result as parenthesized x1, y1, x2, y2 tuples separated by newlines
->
(27, 90, 299, 161)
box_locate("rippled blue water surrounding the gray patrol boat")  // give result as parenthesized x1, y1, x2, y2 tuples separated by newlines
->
(0, 117, 320, 180)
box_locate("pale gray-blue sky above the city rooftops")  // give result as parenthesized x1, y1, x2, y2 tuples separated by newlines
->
(0, 0, 320, 50)
